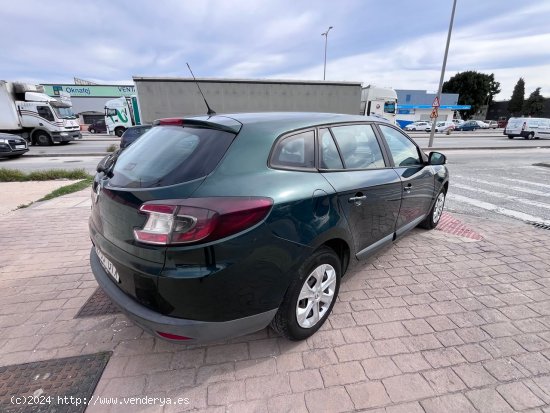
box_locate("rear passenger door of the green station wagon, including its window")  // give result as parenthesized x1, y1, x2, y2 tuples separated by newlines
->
(319, 124, 401, 258)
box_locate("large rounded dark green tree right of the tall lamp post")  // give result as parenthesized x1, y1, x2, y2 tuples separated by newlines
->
(442, 70, 500, 119)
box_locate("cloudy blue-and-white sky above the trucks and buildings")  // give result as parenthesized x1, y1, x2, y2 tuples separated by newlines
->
(0, 0, 550, 99)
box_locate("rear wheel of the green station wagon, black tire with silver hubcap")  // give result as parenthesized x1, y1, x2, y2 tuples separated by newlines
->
(271, 247, 342, 341)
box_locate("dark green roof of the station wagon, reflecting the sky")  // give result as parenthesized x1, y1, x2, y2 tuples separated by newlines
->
(191, 112, 391, 133)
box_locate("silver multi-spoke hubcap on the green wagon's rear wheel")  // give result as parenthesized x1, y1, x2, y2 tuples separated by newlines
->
(296, 264, 336, 328)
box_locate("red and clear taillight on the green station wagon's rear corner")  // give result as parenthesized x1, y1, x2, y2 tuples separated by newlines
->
(134, 198, 273, 245)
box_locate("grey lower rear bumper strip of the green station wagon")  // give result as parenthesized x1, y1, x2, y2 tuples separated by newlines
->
(90, 248, 277, 344)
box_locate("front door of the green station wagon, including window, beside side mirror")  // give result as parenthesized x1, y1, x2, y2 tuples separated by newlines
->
(378, 124, 435, 235)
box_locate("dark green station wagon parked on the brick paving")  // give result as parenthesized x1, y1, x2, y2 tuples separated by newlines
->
(89, 113, 448, 343)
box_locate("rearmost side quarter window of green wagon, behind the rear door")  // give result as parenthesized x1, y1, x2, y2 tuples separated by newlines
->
(270, 131, 315, 169)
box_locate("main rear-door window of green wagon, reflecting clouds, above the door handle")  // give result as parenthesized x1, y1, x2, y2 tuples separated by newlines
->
(331, 125, 386, 169)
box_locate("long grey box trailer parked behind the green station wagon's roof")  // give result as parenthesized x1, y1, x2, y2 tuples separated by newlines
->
(133, 76, 361, 123)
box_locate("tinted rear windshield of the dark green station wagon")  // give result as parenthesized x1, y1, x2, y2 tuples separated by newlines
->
(110, 126, 235, 188)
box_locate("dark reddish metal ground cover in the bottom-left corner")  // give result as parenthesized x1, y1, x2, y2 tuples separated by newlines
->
(0, 352, 111, 413)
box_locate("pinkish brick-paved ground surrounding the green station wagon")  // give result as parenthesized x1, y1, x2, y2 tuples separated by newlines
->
(0, 191, 550, 413)
